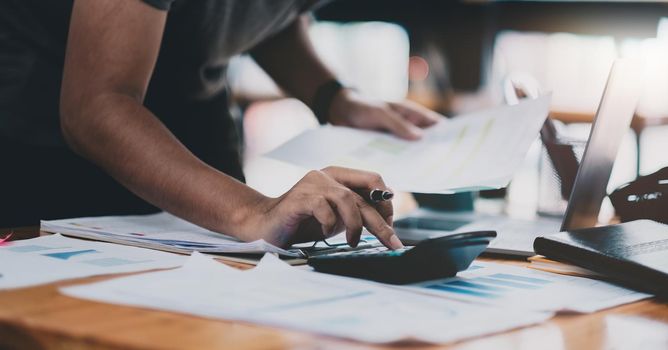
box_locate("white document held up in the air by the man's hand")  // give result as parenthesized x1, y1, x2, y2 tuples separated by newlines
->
(266, 95, 550, 193)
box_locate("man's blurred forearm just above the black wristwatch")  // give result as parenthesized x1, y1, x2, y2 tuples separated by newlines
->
(252, 16, 335, 106)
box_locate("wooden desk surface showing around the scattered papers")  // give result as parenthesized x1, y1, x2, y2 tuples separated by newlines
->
(0, 229, 668, 350)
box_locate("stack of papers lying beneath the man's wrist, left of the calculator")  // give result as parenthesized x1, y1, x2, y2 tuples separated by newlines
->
(41, 212, 302, 257)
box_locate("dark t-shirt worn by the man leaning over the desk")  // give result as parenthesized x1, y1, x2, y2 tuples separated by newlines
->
(0, 0, 319, 168)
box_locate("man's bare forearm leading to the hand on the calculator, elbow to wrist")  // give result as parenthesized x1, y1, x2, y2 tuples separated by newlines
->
(63, 92, 263, 239)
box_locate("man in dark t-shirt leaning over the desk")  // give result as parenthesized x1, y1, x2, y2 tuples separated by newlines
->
(0, 0, 444, 248)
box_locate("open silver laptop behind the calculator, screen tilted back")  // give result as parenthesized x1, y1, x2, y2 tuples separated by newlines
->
(394, 59, 641, 257)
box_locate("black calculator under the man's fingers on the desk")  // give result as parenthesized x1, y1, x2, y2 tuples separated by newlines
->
(308, 231, 496, 284)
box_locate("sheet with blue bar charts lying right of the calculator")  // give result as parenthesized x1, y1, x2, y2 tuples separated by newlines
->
(406, 262, 651, 313)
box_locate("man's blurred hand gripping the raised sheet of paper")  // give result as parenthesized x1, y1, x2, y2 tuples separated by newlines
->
(329, 89, 441, 140)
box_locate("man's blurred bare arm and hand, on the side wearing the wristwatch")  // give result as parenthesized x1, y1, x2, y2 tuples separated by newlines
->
(251, 16, 440, 140)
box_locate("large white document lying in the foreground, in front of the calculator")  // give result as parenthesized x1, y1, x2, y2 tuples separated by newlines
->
(61, 253, 552, 343)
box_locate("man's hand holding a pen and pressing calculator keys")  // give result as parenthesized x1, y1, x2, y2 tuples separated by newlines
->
(244, 167, 403, 249)
